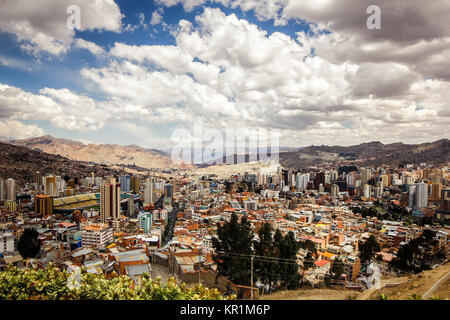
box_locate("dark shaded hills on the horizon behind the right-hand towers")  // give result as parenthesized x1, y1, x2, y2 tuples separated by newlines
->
(280, 139, 450, 169)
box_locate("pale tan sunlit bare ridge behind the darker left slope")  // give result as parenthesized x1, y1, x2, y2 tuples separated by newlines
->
(11, 135, 193, 169)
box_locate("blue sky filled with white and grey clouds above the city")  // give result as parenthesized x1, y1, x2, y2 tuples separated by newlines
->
(0, 0, 450, 150)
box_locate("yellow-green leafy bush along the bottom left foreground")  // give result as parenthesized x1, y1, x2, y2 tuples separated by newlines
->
(0, 265, 234, 300)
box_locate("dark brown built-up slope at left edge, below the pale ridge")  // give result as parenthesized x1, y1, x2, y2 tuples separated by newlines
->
(0, 142, 125, 185)
